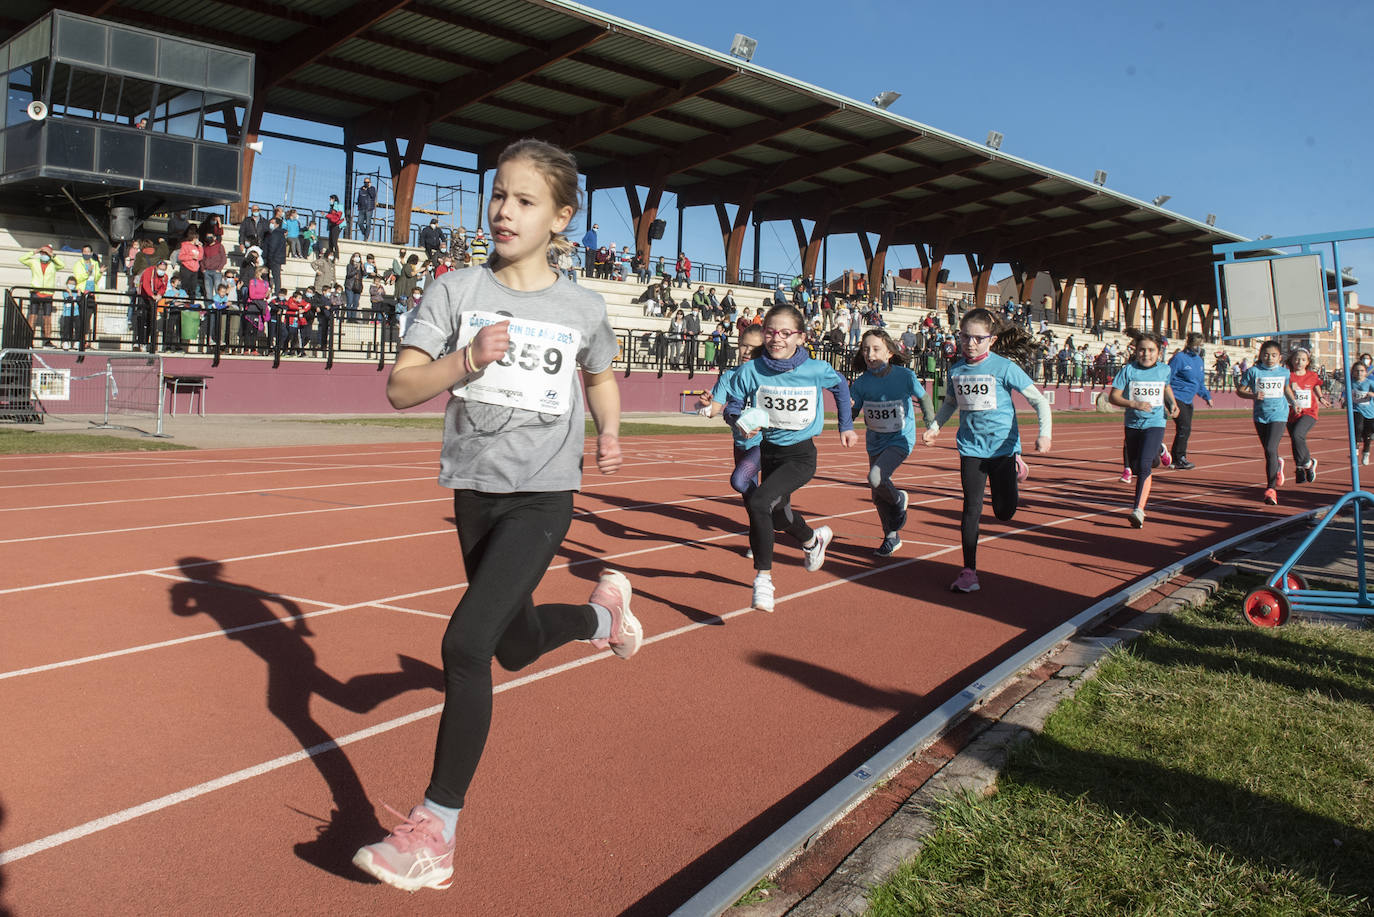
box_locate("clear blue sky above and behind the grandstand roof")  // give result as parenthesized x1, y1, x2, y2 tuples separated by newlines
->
(254, 0, 1374, 302)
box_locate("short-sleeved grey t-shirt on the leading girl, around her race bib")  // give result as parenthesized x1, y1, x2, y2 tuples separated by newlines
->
(401, 267, 617, 494)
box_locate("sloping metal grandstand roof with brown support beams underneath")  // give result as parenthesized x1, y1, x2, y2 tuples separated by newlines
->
(0, 0, 1264, 302)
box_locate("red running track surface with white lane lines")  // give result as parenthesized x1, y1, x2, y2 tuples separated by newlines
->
(0, 420, 1348, 917)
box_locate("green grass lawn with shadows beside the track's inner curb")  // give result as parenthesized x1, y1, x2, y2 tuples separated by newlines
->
(868, 579, 1374, 917)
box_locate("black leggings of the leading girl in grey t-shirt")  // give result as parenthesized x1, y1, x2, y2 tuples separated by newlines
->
(425, 491, 596, 808)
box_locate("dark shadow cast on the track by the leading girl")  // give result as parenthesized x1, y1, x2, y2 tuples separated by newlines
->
(170, 557, 444, 883)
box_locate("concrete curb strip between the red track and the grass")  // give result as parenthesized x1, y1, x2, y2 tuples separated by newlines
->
(774, 565, 1237, 917)
